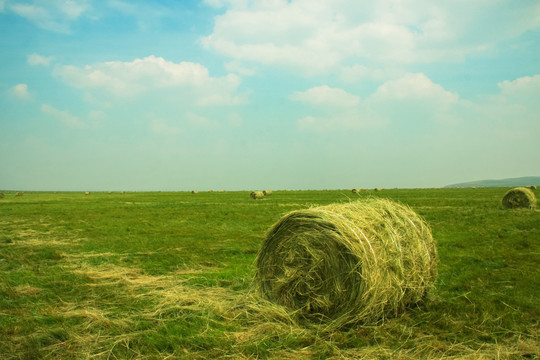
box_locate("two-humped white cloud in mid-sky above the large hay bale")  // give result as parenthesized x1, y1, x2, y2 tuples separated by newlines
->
(296, 74, 460, 131)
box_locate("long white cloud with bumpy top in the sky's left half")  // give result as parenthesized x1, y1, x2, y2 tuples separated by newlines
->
(55, 55, 246, 106)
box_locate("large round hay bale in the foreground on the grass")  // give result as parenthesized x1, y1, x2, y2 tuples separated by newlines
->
(255, 199, 438, 328)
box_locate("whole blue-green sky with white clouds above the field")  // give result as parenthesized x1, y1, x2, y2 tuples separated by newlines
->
(0, 0, 540, 190)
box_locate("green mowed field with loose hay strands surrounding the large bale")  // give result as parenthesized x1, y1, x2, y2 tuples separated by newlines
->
(0, 188, 540, 359)
